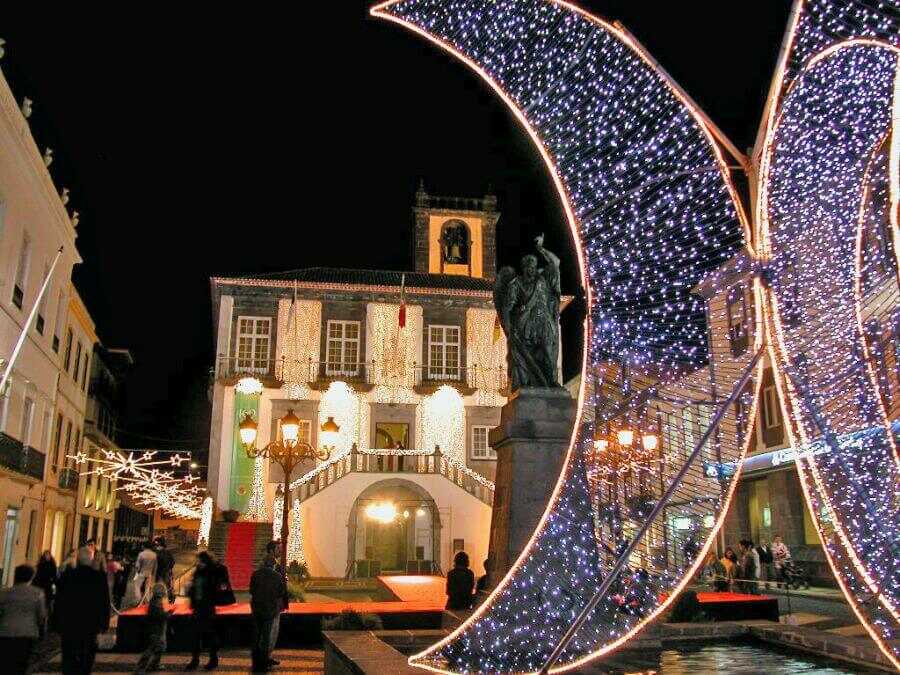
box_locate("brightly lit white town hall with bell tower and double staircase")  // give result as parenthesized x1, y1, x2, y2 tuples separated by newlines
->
(208, 188, 565, 577)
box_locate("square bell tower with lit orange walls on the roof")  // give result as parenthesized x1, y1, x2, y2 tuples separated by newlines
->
(413, 182, 500, 279)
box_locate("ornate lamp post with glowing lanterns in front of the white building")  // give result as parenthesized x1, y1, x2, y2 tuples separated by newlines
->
(238, 409, 340, 572)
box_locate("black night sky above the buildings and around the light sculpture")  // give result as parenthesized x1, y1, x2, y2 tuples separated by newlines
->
(0, 0, 790, 447)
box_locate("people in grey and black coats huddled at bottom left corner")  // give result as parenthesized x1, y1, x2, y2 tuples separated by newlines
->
(0, 540, 111, 674)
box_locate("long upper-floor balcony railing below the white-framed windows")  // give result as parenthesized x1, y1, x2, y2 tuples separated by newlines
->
(215, 356, 508, 393)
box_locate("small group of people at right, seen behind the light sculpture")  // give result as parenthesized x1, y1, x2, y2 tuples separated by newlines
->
(709, 535, 791, 595)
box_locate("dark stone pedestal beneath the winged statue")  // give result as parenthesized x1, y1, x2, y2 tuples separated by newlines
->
(489, 388, 576, 587)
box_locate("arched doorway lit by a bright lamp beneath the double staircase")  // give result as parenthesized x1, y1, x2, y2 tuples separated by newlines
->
(348, 478, 441, 576)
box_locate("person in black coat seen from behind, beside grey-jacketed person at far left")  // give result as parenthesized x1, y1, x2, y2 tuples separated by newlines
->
(53, 547, 110, 675)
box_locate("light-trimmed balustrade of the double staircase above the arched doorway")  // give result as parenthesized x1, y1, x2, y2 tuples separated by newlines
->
(291, 445, 494, 506)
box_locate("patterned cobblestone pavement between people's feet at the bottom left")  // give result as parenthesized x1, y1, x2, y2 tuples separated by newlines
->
(35, 649, 325, 673)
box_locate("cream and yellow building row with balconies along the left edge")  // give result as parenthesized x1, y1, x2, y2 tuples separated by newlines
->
(0, 67, 90, 584)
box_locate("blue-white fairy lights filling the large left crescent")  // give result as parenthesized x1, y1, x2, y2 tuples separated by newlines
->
(378, 0, 753, 673)
